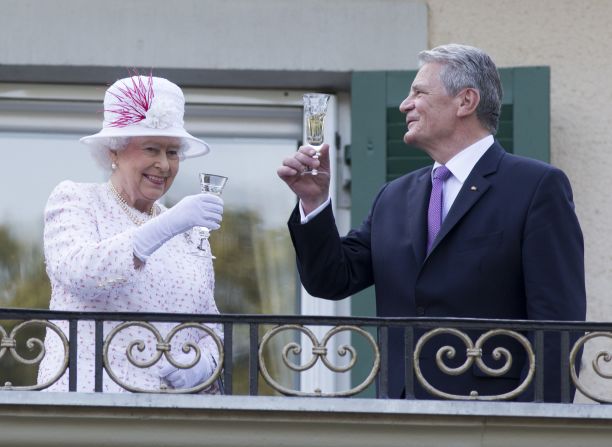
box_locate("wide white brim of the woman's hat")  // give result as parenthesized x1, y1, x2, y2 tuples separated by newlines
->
(79, 126, 210, 158)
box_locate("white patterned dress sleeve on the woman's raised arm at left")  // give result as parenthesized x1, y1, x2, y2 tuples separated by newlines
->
(44, 181, 140, 298)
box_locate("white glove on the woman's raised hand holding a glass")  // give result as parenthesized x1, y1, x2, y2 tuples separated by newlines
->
(134, 194, 223, 262)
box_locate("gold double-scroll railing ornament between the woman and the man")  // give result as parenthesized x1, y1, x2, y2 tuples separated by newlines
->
(259, 324, 380, 397)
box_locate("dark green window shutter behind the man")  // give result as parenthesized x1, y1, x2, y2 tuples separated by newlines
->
(350, 67, 550, 395)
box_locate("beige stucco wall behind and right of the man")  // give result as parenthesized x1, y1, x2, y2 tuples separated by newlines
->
(427, 0, 612, 402)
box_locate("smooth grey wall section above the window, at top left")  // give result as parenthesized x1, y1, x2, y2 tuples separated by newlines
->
(0, 0, 427, 71)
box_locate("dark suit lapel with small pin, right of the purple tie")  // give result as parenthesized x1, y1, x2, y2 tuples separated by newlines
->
(425, 143, 505, 253)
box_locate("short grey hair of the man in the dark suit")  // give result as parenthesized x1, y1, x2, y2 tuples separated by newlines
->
(418, 43, 503, 135)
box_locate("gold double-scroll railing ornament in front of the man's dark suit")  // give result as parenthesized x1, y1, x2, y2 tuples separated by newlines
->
(413, 328, 535, 400)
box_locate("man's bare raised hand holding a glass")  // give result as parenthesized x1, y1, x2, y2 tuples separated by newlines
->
(276, 144, 330, 214)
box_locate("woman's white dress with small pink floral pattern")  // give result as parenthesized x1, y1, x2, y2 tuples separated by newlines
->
(38, 181, 223, 392)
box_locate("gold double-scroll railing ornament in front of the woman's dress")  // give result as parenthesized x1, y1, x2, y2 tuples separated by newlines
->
(103, 321, 224, 394)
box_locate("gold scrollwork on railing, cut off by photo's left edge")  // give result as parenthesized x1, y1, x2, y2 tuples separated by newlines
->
(0, 320, 69, 390)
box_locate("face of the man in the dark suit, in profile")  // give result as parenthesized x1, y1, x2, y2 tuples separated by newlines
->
(400, 62, 459, 153)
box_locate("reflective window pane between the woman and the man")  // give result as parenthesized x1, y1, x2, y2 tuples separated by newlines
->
(167, 138, 297, 314)
